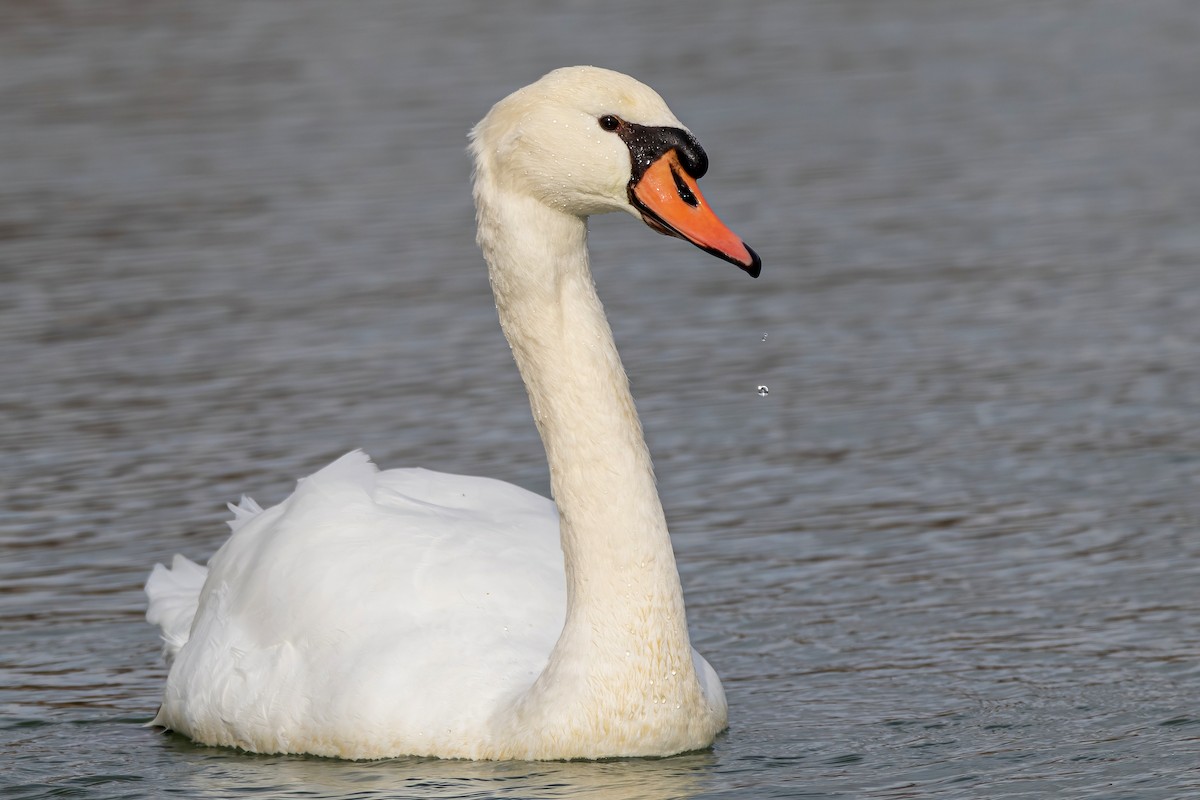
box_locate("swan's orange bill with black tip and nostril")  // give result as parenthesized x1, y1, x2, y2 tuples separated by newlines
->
(629, 149, 762, 277)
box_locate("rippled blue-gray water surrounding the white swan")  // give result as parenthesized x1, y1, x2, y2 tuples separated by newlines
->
(0, 0, 1200, 799)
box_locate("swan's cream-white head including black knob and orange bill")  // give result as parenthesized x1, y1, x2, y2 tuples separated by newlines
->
(470, 67, 762, 277)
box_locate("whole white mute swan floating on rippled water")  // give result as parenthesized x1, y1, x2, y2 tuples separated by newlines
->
(145, 67, 761, 759)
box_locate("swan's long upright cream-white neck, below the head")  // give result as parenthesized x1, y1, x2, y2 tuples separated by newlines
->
(476, 176, 724, 758)
